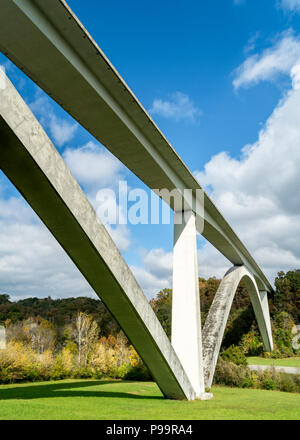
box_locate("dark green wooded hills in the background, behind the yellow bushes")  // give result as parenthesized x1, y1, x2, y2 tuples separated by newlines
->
(0, 270, 300, 357)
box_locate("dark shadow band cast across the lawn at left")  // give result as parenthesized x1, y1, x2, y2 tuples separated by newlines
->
(0, 380, 163, 401)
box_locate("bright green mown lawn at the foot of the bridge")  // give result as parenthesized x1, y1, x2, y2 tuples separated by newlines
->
(0, 380, 300, 420)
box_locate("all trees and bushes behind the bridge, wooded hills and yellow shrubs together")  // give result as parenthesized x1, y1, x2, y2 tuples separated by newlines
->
(0, 270, 300, 392)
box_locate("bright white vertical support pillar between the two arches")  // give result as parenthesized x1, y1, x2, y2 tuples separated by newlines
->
(172, 211, 204, 398)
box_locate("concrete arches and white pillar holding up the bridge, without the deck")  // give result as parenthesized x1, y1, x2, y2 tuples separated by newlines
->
(0, 67, 272, 400)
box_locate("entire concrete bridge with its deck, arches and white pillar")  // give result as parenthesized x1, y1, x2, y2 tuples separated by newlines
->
(0, 0, 272, 399)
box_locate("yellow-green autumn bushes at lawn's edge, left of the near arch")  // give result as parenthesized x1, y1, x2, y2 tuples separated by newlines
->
(0, 312, 151, 383)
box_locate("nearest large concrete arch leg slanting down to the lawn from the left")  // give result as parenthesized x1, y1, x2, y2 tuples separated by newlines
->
(0, 70, 195, 400)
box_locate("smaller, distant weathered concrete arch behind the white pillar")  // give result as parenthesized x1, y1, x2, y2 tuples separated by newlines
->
(203, 266, 273, 387)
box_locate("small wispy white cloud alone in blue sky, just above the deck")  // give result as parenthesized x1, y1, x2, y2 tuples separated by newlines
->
(149, 92, 201, 122)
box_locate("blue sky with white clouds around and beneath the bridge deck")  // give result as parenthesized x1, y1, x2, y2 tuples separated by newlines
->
(0, 0, 300, 299)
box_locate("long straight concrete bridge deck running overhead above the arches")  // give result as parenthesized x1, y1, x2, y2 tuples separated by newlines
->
(0, 0, 272, 291)
